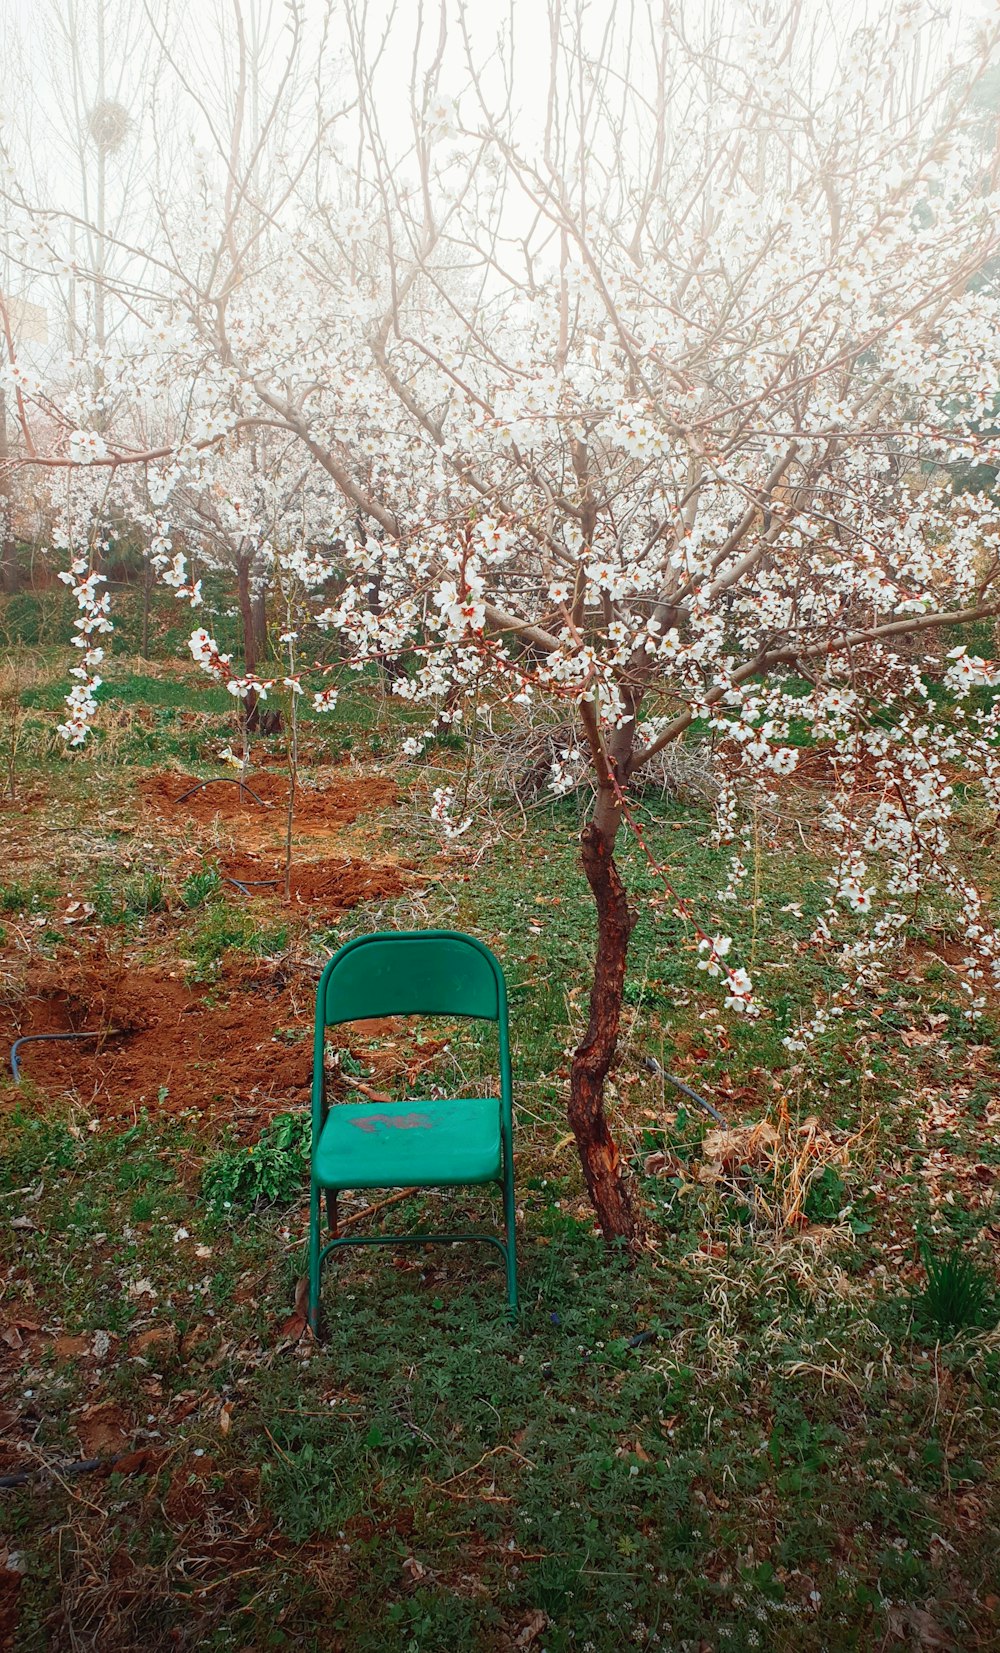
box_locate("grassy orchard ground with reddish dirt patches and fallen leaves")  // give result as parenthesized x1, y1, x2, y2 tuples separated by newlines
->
(0, 593, 1000, 1653)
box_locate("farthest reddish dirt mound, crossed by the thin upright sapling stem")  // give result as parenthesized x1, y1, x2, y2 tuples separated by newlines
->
(142, 770, 397, 827)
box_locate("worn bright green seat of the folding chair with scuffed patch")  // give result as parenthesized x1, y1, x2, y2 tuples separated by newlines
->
(312, 1096, 502, 1190)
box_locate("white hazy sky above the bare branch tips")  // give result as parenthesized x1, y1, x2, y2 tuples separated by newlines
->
(0, 0, 997, 365)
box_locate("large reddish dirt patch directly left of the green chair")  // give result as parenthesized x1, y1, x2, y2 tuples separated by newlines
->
(0, 962, 312, 1124)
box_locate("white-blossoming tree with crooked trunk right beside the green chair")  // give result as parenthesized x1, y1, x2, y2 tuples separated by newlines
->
(1, 3, 1000, 1241)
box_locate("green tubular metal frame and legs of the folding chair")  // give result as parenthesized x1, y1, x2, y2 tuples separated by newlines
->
(309, 929, 517, 1336)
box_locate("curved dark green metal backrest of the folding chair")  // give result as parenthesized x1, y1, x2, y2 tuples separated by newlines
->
(312, 931, 512, 1141)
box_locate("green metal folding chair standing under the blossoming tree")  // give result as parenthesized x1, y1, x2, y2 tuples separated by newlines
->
(309, 931, 517, 1336)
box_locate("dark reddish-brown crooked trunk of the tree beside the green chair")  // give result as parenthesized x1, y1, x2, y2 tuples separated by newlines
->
(569, 805, 640, 1246)
